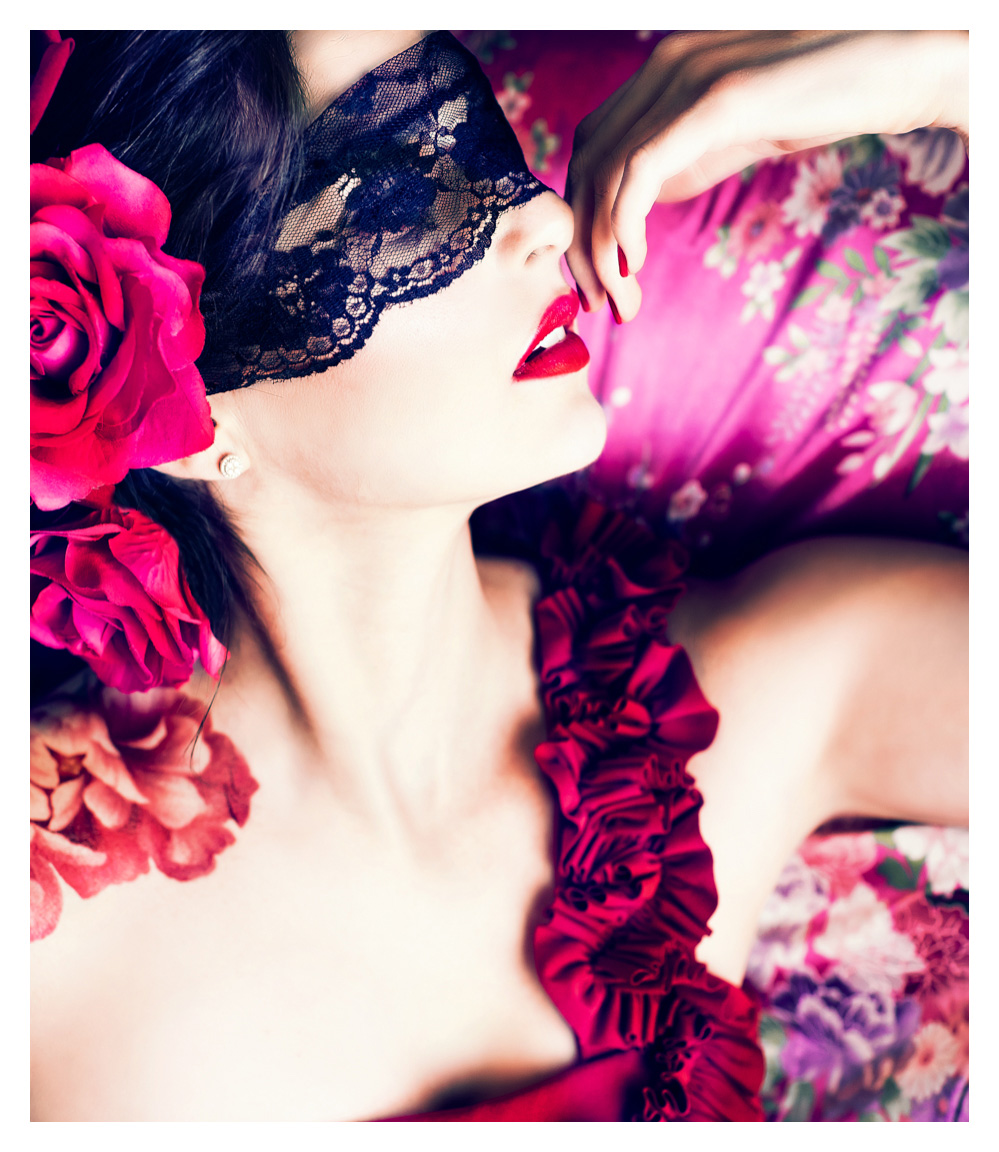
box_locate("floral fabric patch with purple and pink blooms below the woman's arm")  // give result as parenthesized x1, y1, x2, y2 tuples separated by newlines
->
(749, 825, 968, 1121)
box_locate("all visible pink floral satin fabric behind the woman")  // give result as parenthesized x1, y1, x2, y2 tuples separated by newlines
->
(461, 32, 969, 1120)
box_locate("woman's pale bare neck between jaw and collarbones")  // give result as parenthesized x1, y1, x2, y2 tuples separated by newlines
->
(212, 481, 537, 824)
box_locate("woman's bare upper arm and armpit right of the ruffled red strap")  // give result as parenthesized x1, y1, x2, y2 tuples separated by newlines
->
(671, 538, 968, 983)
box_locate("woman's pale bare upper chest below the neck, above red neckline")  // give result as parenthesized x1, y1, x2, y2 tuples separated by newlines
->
(32, 774, 576, 1120)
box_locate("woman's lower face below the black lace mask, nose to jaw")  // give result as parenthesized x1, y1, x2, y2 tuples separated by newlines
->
(212, 192, 606, 507)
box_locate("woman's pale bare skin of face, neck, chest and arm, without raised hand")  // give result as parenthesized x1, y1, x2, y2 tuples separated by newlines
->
(32, 32, 967, 1120)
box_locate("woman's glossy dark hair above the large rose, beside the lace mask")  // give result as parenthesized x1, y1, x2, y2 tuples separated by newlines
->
(31, 31, 305, 269)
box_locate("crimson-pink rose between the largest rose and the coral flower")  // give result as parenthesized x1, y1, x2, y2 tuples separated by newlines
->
(31, 506, 226, 692)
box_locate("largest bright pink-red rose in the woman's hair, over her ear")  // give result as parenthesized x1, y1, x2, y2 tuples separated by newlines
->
(31, 144, 213, 508)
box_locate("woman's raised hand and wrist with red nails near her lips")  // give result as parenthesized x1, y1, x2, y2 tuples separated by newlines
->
(566, 31, 968, 320)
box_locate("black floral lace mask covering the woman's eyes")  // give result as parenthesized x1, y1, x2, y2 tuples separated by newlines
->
(198, 32, 545, 393)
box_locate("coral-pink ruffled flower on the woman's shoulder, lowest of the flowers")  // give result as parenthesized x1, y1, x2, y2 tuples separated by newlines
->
(31, 689, 257, 940)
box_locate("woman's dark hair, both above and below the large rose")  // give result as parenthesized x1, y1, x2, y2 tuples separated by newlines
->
(31, 31, 306, 700)
